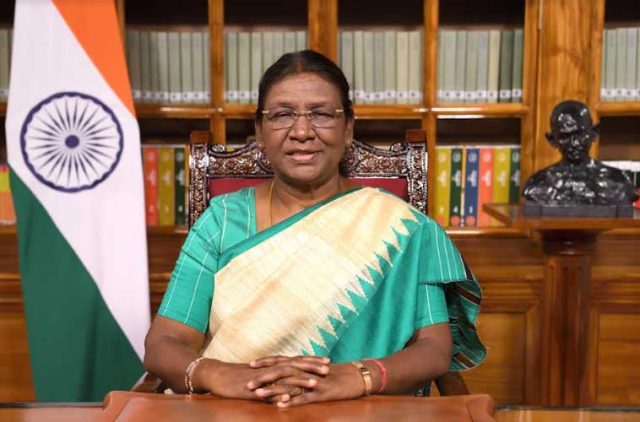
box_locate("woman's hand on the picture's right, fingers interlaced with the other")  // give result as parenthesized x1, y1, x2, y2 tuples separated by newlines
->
(251, 363, 365, 408)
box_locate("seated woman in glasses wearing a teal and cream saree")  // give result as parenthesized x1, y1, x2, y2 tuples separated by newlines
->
(144, 50, 485, 407)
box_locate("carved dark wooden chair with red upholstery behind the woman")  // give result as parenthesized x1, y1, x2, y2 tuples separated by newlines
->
(134, 130, 469, 395)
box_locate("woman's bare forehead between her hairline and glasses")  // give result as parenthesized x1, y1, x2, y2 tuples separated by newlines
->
(265, 73, 340, 105)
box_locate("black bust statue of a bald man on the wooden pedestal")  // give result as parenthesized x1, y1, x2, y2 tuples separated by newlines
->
(522, 100, 638, 217)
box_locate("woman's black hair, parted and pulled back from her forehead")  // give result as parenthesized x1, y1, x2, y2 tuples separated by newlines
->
(255, 50, 353, 123)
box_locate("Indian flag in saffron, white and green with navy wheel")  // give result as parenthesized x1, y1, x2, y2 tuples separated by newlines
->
(6, 0, 150, 401)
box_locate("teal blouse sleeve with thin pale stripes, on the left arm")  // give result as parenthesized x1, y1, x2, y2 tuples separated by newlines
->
(158, 207, 220, 333)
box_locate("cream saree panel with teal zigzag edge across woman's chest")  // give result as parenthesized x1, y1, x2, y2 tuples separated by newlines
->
(203, 188, 417, 362)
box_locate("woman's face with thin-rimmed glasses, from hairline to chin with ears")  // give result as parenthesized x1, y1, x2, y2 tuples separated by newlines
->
(256, 73, 353, 186)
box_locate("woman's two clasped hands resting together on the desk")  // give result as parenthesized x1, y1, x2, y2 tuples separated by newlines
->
(194, 356, 365, 407)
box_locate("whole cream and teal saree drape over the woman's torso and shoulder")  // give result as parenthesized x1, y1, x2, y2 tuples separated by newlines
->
(203, 188, 485, 370)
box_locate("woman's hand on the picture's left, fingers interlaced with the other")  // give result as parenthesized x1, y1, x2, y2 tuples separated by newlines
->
(192, 356, 329, 402)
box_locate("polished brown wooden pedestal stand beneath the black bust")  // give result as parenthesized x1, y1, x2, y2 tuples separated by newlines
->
(484, 204, 640, 406)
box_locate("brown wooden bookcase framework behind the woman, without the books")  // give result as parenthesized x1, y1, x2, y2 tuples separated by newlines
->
(0, 0, 640, 404)
